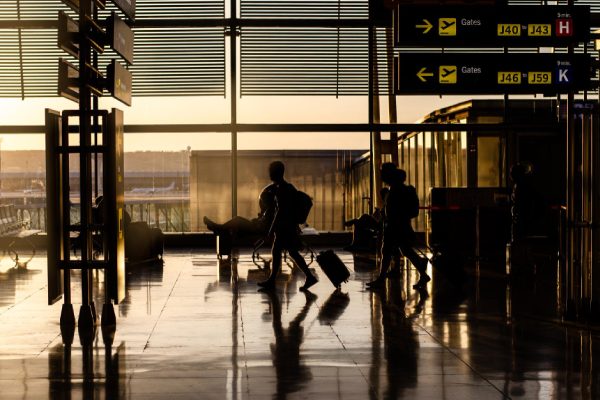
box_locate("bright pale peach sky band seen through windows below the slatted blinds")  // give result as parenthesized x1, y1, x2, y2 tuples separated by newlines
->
(0, 96, 502, 151)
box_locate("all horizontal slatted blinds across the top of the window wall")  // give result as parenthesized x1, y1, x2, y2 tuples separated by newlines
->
(0, 0, 600, 97)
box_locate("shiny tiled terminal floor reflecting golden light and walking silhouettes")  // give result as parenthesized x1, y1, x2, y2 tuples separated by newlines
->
(0, 250, 600, 400)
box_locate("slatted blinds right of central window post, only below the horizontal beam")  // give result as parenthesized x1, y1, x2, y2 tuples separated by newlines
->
(240, 28, 388, 96)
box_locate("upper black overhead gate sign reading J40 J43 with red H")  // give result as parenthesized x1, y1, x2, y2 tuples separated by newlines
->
(394, 5, 590, 47)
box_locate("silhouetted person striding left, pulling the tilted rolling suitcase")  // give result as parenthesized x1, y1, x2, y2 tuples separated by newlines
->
(258, 161, 318, 290)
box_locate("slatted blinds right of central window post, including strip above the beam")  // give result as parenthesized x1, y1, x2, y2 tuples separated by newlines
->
(240, 0, 388, 96)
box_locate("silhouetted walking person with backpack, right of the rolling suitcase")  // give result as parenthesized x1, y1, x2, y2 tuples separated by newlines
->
(367, 163, 431, 289)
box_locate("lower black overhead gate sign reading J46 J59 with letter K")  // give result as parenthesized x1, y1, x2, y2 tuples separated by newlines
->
(394, 53, 592, 94)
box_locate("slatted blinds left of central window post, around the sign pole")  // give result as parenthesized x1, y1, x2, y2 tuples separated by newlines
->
(0, 0, 225, 97)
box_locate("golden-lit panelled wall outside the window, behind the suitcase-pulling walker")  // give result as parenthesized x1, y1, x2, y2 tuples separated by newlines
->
(190, 144, 368, 231)
